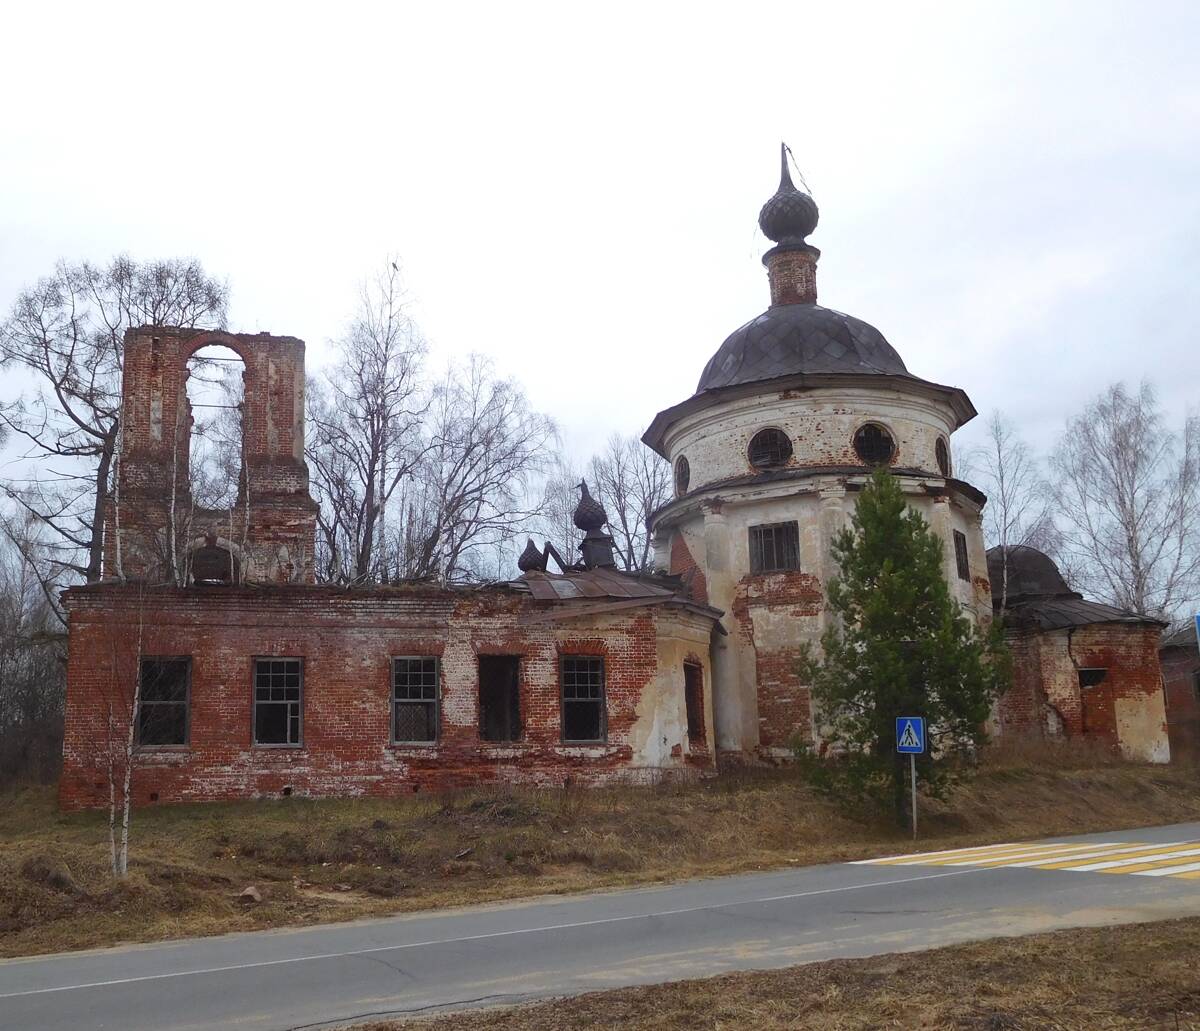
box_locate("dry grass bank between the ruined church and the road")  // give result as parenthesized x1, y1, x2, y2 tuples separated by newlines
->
(0, 751, 1200, 957)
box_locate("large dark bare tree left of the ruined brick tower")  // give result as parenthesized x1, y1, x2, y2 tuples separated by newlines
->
(0, 257, 229, 581)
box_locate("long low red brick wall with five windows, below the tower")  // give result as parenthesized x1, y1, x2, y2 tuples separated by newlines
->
(60, 585, 710, 809)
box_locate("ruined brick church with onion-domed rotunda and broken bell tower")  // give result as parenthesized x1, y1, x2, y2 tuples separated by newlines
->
(60, 149, 1171, 808)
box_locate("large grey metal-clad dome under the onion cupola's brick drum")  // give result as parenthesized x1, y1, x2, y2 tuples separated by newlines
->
(696, 304, 908, 394)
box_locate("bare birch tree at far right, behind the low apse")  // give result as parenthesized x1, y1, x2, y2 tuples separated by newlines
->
(1050, 383, 1200, 618)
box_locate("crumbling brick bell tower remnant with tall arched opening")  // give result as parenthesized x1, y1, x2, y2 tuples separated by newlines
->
(104, 328, 317, 583)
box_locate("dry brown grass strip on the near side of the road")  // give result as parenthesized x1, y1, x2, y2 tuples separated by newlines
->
(360, 918, 1200, 1031)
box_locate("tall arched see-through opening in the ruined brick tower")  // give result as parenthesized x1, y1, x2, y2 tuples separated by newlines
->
(180, 344, 246, 510)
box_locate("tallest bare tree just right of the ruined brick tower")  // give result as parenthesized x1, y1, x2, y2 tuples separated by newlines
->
(306, 260, 428, 582)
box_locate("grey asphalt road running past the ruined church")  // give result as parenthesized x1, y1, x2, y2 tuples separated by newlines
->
(0, 823, 1200, 1031)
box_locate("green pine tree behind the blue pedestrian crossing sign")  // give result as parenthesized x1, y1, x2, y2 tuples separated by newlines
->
(800, 469, 1009, 823)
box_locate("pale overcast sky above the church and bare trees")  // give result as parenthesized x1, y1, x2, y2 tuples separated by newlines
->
(0, 0, 1200, 455)
